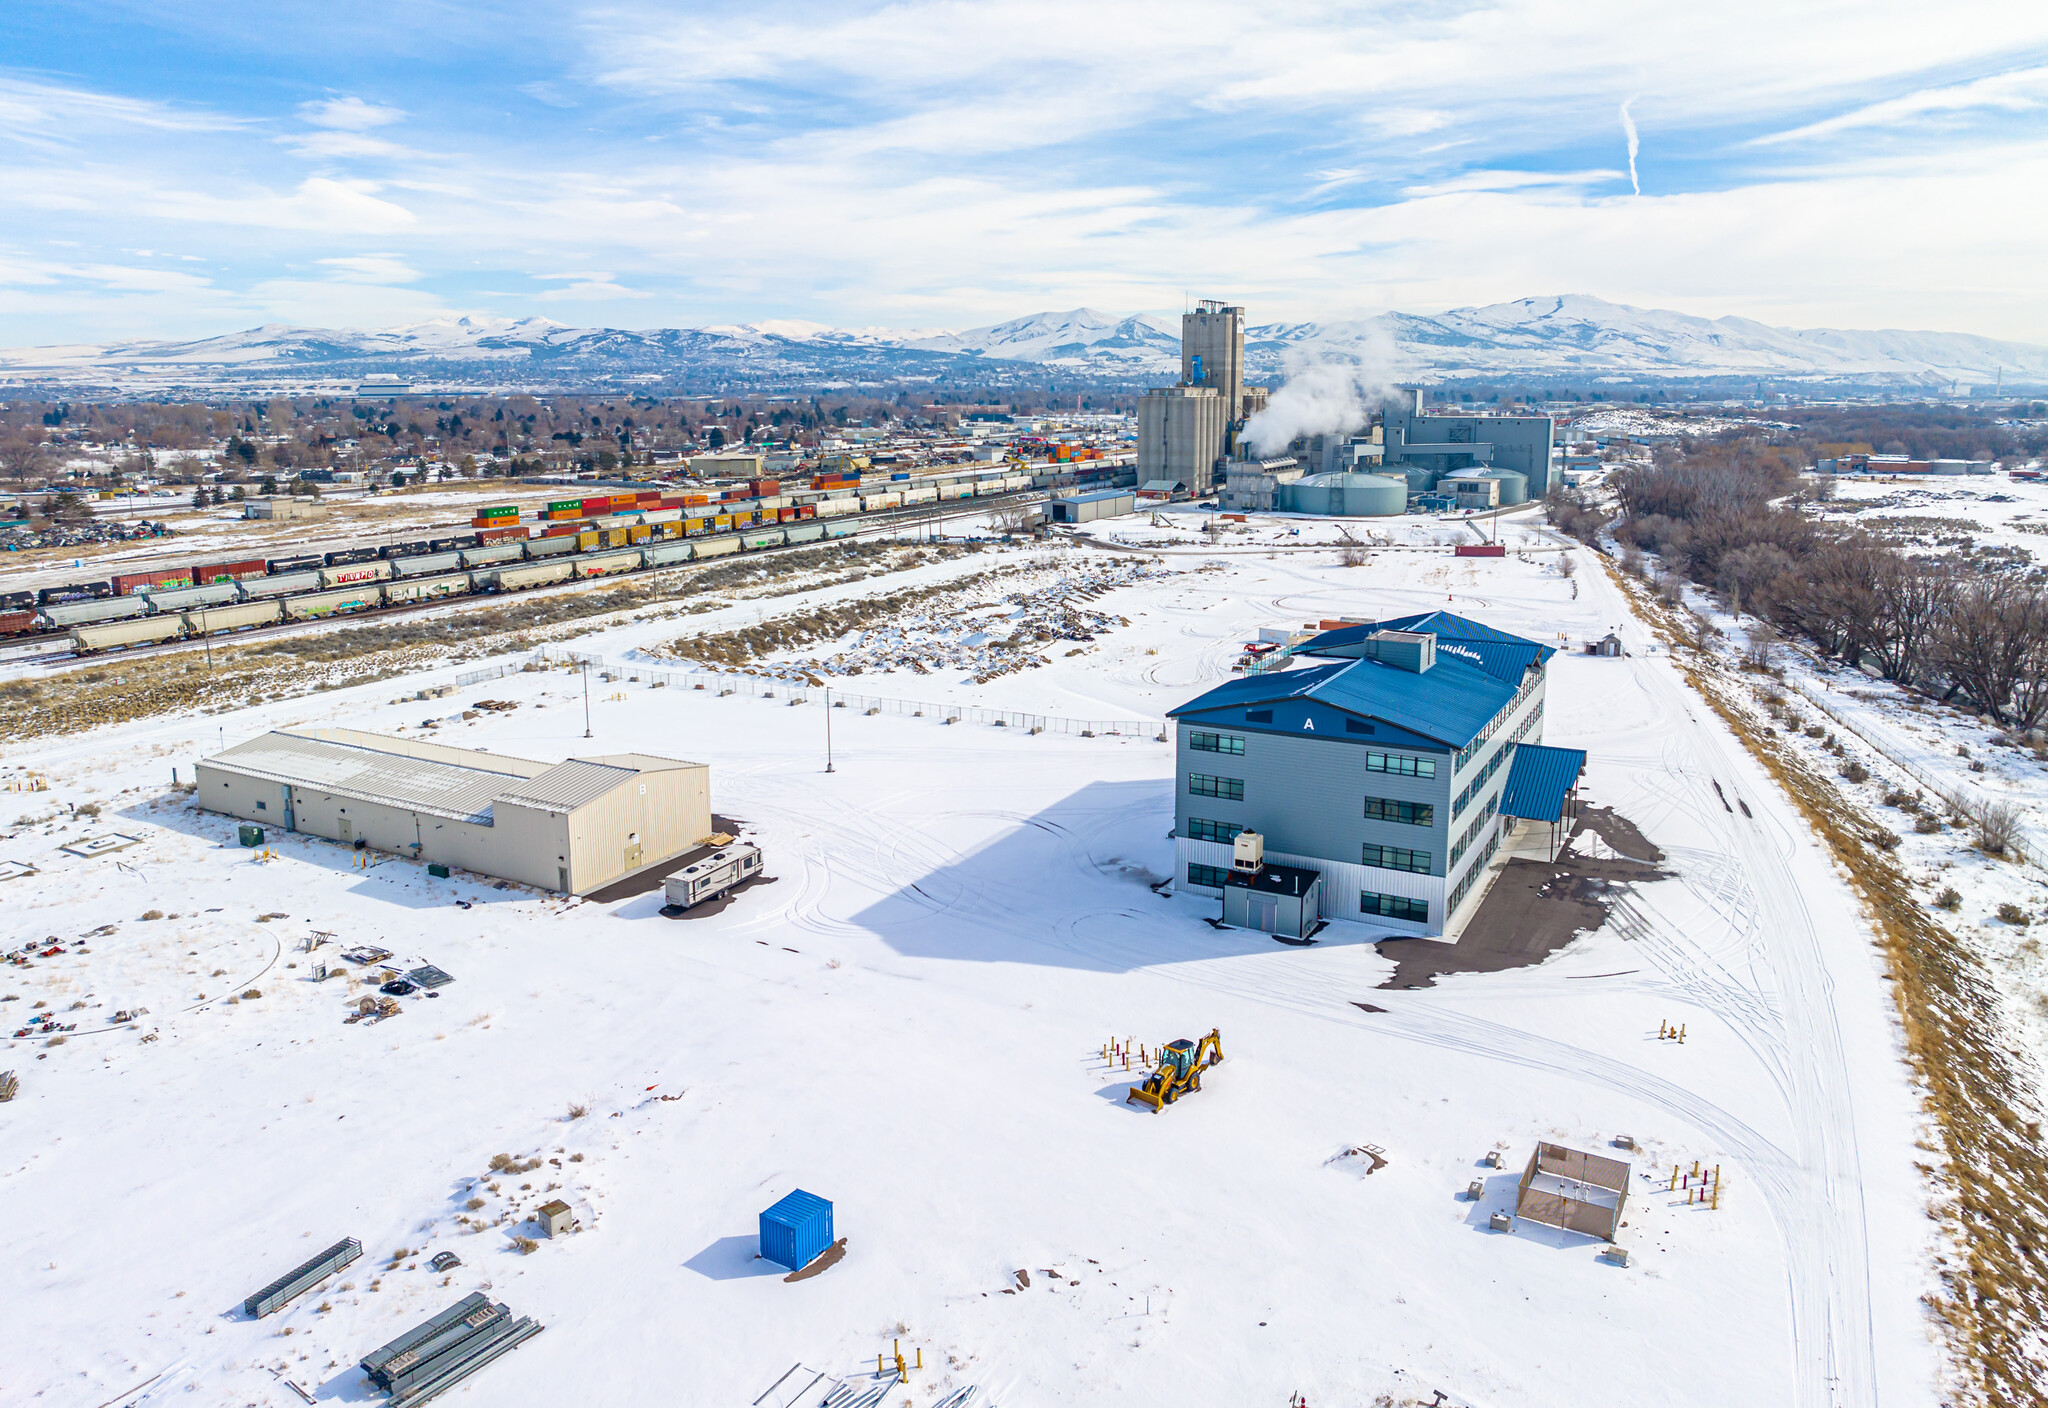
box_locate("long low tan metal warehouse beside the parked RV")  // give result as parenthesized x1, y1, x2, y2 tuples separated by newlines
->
(197, 729, 711, 894)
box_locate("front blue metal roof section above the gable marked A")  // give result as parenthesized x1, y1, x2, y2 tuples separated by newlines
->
(1167, 654, 1518, 749)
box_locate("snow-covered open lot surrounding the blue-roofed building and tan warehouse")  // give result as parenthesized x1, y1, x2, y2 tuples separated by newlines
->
(0, 520, 1937, 1408)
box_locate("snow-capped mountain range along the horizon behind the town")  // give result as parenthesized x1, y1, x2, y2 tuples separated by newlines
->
(0, 295, 2048, 395)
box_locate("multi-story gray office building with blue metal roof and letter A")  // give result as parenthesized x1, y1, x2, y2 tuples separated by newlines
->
(1169, 612, 1585, 935)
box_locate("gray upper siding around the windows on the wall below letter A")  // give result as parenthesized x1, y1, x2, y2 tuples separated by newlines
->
(1174, 720, 1450, 880)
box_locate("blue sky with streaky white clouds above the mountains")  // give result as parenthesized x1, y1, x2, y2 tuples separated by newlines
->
(0, 0, 2048, 346)
